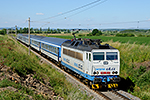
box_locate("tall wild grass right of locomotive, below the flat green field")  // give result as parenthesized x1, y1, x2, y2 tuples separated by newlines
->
(108, 41, 150, 100)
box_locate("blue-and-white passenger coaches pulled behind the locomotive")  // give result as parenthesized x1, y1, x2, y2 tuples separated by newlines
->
(17, 34, 70, 62)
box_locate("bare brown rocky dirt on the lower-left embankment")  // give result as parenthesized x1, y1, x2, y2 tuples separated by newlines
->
(0, 64, 64, 100)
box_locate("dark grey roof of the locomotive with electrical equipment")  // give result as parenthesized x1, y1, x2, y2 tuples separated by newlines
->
(63, 40, 116, 52)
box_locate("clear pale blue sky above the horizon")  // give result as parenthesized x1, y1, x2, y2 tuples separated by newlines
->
(0, 0, 150, 29)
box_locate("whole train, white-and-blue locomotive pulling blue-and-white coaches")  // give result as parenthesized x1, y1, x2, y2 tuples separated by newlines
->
(17, 34, 120, 89)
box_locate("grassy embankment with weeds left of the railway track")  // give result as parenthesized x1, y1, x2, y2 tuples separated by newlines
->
(0, 35, 91, 100)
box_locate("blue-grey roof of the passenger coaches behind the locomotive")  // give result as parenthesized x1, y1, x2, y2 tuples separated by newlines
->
(18, 34, 70, 46)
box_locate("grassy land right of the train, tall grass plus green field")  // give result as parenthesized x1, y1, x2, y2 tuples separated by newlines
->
(47, 36, 150, 100)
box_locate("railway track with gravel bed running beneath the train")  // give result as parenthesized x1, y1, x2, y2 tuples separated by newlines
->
(12, 36, 140, 100)
